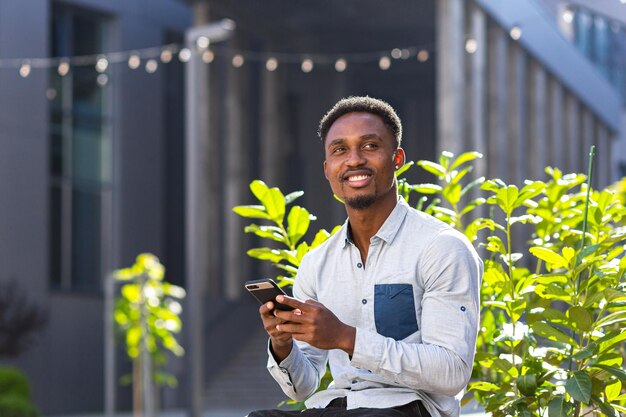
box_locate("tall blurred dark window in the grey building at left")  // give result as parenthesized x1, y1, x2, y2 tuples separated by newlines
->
(48, 3, 112, 292)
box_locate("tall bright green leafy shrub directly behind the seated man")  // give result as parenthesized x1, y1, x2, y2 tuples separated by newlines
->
(235, 152, 626, 417)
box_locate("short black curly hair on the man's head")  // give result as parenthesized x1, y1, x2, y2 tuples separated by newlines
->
(317, 96, 402, 148)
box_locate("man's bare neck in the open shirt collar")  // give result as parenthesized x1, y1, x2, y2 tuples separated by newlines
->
(346, 193, 398, 264)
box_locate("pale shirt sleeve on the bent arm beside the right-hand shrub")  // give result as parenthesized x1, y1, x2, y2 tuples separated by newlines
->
(351, 230, 482, 396)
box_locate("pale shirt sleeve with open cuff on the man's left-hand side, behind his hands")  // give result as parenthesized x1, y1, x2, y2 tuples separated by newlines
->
(267, 252, 328, 401)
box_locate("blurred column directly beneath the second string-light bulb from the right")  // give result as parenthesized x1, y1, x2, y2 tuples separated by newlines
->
(507, 44, 528, 185)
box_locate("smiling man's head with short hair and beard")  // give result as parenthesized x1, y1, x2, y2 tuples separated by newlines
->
(320, 97, 404, 210)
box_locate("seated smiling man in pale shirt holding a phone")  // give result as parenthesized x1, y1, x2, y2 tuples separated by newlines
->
(249, 97, 482, 417)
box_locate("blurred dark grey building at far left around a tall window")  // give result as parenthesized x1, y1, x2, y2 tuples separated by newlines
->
(0, 0, 192, 414)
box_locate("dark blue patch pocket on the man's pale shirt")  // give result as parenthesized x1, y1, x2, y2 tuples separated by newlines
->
(374, 284, 419, 340)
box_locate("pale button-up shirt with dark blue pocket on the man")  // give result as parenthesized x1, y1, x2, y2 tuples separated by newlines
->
(268, 197, 482, 417)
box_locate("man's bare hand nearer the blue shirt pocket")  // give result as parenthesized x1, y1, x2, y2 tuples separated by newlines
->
(266, 295, 356, 356)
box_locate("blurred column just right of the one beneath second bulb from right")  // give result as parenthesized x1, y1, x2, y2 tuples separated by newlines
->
(528, 61, 550, 179)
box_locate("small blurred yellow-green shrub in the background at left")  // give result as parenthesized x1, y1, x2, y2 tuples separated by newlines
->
(114, 253, 185, 409)
